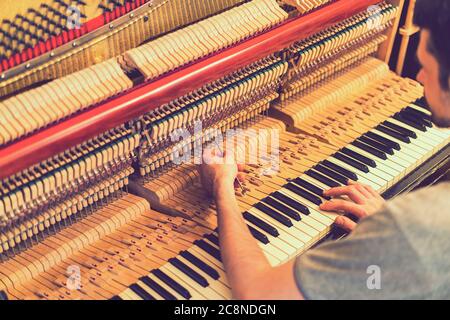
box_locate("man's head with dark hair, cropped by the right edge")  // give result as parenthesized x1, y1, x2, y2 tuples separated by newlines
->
(415, 0, 450, 127)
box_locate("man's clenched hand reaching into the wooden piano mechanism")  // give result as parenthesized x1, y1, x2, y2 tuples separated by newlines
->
(198, 149, 245, 196)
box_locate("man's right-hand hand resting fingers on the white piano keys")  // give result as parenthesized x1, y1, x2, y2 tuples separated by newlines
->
(320, 182, 385, 231)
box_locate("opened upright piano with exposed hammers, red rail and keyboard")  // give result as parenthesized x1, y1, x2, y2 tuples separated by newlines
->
(0, 0, 450, 300)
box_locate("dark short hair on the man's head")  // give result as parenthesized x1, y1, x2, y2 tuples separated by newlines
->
(414, 0, 450, 91)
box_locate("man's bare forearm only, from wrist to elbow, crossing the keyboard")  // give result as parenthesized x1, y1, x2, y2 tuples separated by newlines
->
(214, 182, 271, 298)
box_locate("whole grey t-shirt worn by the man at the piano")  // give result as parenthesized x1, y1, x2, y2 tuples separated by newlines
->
(294, 182, 450, 299)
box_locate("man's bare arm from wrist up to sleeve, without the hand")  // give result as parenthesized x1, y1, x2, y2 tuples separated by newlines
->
(214, 180, 303, 300)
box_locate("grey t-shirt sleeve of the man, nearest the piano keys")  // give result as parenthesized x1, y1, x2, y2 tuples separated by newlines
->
(294, 209, 430, 300)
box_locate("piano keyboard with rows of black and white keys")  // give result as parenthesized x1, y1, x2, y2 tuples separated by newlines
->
(117, 97, 450, 300)
